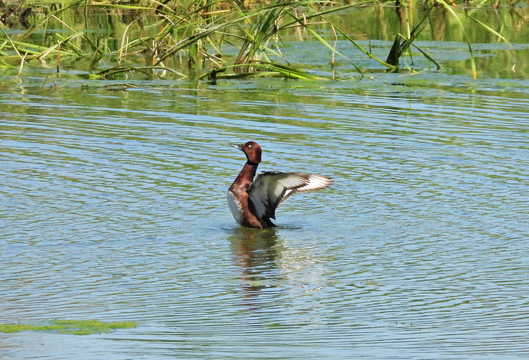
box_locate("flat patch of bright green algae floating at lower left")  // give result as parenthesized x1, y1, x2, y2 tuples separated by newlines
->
(0, 320, 137, 335)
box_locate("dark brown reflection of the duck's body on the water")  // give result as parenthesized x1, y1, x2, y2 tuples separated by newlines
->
(229, 227, 278, 297)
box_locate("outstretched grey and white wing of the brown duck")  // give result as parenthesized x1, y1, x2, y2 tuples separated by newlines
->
(248, 171, 332, 220)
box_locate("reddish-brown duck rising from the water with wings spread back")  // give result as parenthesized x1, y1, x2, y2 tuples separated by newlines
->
(227, 141, 332, 229)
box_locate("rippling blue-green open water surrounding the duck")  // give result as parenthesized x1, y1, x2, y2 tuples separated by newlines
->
(0, 75, 529, 359)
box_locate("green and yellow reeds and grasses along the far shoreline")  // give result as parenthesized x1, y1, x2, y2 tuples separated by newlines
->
(0, 0, 517, 83)
